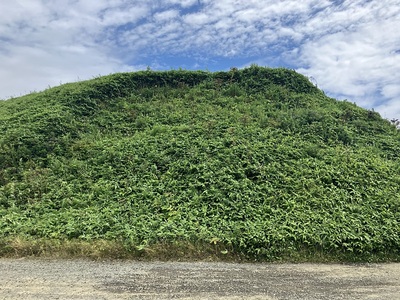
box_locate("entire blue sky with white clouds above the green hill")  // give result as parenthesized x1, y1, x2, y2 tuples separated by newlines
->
(0, 0, 400, 119)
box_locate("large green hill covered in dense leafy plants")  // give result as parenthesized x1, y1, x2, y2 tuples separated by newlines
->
(0, 66, 400, 261)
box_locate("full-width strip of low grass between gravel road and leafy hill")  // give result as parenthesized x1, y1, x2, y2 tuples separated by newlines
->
(0, 238, 400, 263)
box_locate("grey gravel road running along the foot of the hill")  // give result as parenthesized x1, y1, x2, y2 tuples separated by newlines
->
(0, 259, 400, 300)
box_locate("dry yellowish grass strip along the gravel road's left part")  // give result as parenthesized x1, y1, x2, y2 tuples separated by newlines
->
(0, 237, 246, 261)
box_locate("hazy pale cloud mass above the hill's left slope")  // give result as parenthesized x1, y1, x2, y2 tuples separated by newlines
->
(0, 0, 138, 98)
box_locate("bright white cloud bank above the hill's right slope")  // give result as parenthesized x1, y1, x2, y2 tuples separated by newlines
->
(297, 0, 400, 117)
